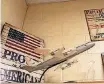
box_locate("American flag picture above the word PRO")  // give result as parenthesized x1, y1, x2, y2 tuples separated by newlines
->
(2, 23, 44, 59)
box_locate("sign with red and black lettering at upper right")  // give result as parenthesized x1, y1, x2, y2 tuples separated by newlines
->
(84, 8, 104, 41)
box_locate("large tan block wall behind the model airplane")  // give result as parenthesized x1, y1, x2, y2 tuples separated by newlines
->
(23, 0, 104, 82)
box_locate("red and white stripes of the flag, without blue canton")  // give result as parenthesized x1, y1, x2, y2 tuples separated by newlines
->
(2, 27, 44, 59)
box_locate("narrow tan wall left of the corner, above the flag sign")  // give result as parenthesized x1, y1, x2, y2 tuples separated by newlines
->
(1, 0, 27, 28)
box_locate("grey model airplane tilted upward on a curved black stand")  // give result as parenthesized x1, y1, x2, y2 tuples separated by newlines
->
(22, 42, 95, 72)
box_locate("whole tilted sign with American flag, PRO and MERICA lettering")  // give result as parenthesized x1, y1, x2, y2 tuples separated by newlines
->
(0, 23, 44, 83)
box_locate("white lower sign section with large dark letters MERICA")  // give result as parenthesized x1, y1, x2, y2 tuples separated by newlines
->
(0, 64, 40, 83)
